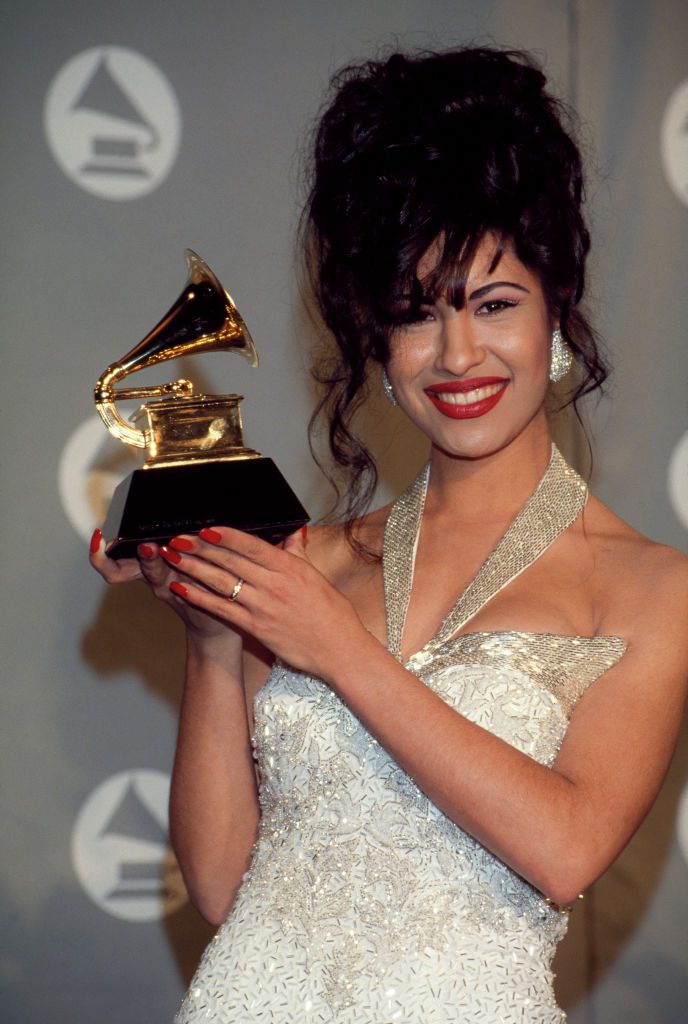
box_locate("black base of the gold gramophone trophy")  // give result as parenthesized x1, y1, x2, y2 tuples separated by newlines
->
(103, 459, 309, 558)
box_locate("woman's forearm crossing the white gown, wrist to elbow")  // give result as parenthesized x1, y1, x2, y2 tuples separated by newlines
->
(327, 637, 588, 902)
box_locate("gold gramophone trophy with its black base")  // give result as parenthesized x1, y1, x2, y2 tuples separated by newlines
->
(94, 249, 308, 558)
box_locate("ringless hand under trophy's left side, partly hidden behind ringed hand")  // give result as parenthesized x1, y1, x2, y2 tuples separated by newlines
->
(89, 529, 233, 639)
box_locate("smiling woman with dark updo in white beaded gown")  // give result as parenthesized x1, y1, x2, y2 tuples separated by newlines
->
(92, 49, 688, 1024)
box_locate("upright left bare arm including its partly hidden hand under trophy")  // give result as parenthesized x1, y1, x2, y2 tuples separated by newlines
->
(91, 536, 270, 924)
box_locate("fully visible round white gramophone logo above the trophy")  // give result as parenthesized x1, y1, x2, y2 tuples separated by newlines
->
(44, 46, 181, 200)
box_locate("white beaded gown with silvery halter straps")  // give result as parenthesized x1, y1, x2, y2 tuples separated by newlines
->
(175, 449, 626, 1024)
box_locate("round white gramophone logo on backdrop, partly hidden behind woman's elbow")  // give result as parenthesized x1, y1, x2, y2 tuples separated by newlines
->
(72, 770, 186, 922)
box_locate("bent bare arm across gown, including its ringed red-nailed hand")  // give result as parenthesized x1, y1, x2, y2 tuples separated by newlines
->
(159, 530, 688, 903)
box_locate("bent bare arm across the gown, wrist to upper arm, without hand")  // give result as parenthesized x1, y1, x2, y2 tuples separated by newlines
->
(329, 598, 688, 904)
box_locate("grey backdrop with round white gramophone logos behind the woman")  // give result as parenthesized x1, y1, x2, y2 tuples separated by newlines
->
(0, 0, 688, 1024)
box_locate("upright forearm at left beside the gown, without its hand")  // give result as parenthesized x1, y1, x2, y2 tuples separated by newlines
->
(170, 637, 259, 924)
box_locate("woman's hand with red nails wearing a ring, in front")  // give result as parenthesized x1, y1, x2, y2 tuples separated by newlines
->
(161, 526, 369, 681)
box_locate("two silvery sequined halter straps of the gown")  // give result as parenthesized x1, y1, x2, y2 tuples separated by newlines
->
(382, 444, 588, 660)
